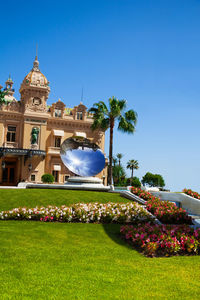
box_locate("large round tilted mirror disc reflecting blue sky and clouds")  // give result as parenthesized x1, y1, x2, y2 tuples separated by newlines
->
(60, 137, 105, 176)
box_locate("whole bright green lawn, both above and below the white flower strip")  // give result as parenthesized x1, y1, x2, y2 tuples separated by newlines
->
(0, 190, 200, 300)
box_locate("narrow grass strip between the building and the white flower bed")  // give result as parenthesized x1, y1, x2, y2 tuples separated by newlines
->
(0, 189, 129, 210)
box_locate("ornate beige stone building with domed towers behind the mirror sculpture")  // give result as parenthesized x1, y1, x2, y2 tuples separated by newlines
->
(0, 56, 107, 185)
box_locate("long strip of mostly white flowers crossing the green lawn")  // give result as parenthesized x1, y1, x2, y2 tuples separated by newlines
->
(0, 202, 155, 224)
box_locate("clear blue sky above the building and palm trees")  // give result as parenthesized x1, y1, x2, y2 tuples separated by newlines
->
(0, 0, 200, 192)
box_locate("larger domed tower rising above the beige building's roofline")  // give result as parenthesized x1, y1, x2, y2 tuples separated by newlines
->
(20, 56, 50, 113)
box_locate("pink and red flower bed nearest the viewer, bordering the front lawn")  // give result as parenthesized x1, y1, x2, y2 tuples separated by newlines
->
(120, 223, 200, 257)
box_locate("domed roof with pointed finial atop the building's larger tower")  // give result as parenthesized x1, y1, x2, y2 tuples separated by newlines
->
(23, 56, 49, 87)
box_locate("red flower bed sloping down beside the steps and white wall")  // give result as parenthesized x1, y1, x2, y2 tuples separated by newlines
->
(131, 187, 192, 224)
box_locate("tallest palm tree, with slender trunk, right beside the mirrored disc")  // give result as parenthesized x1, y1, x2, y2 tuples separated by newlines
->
(89, 97, 137, 184)
